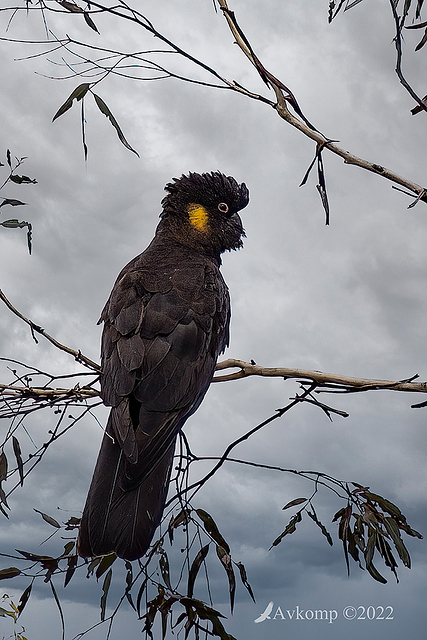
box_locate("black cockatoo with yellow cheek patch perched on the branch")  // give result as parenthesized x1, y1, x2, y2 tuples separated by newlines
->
(77, 171, 249, 561)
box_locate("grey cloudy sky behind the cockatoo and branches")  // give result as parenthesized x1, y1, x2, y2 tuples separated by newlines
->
(0, 0, 427, 640)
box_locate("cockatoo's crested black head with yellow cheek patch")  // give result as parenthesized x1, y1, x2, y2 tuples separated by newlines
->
(159, 171, 249, 255)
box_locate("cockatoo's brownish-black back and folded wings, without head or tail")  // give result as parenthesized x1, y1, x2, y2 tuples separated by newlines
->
(101, 254, 229, 486)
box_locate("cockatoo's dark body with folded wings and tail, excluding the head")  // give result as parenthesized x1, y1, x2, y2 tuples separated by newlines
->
(78, 252, 229, 559)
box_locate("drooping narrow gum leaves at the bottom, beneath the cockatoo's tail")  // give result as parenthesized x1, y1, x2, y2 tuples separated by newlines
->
(0, 509, 254, 640)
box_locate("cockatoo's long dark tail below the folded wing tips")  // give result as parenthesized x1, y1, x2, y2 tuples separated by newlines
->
(77, 424, 175, 560)
